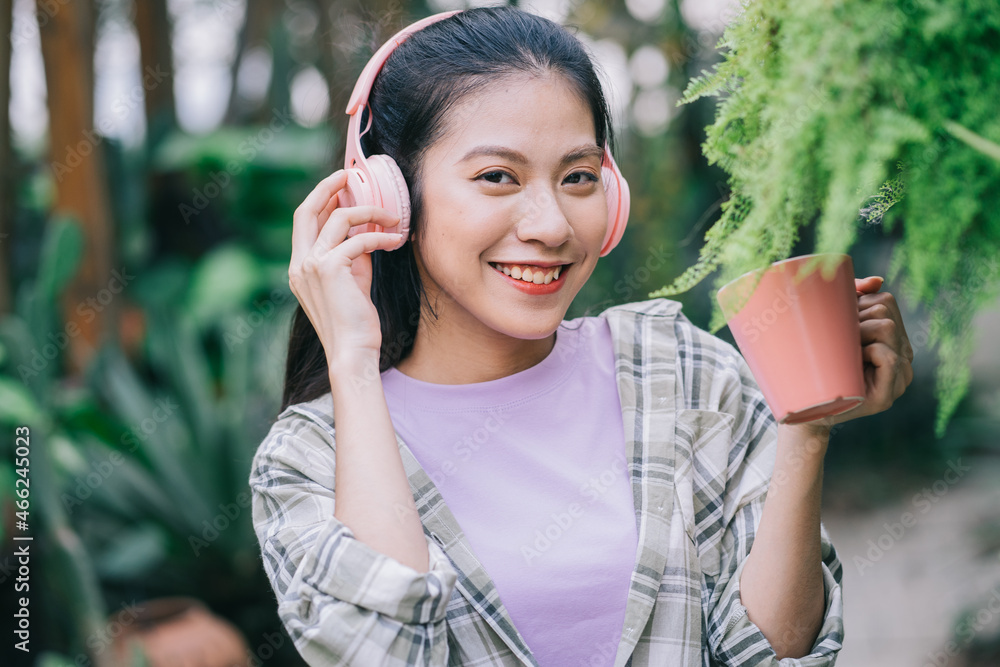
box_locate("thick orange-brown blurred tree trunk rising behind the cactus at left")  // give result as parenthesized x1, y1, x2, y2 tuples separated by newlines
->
(37, 0, 118, 376)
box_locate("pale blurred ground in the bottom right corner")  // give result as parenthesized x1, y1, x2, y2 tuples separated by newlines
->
(823, 458, 1000, 667)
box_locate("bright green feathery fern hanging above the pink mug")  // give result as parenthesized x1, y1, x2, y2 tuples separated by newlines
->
(649, 0, 1000, 438)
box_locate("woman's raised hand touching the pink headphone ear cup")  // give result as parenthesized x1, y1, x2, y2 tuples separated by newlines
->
(288, 169, 400, 366)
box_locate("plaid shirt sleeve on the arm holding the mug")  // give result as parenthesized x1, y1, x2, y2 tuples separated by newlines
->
(680, 315, 844, 667)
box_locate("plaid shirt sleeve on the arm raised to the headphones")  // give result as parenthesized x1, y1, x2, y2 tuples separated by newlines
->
(250, 407, 458, 667)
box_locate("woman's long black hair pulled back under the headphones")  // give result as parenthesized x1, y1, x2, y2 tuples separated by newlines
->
(281, 6, 614, 411)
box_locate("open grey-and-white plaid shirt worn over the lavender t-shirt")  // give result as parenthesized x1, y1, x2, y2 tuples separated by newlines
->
(250, 299, 844, 667)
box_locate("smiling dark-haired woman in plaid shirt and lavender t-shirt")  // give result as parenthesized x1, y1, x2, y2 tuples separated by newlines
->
(250, 7, 912, 667)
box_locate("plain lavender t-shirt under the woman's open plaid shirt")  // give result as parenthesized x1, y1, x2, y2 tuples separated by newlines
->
(382, 317, 638, 667)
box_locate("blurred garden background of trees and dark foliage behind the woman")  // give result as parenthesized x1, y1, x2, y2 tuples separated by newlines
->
(0, 0, 1000, 665)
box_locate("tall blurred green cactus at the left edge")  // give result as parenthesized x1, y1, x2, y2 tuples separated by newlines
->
(0, 218, 118, 667)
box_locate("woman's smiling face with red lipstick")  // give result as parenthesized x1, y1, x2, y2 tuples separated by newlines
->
(414, 74, 609, 339)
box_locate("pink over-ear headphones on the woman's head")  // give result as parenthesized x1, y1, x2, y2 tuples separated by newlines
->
(338, 10, 629, 257)
